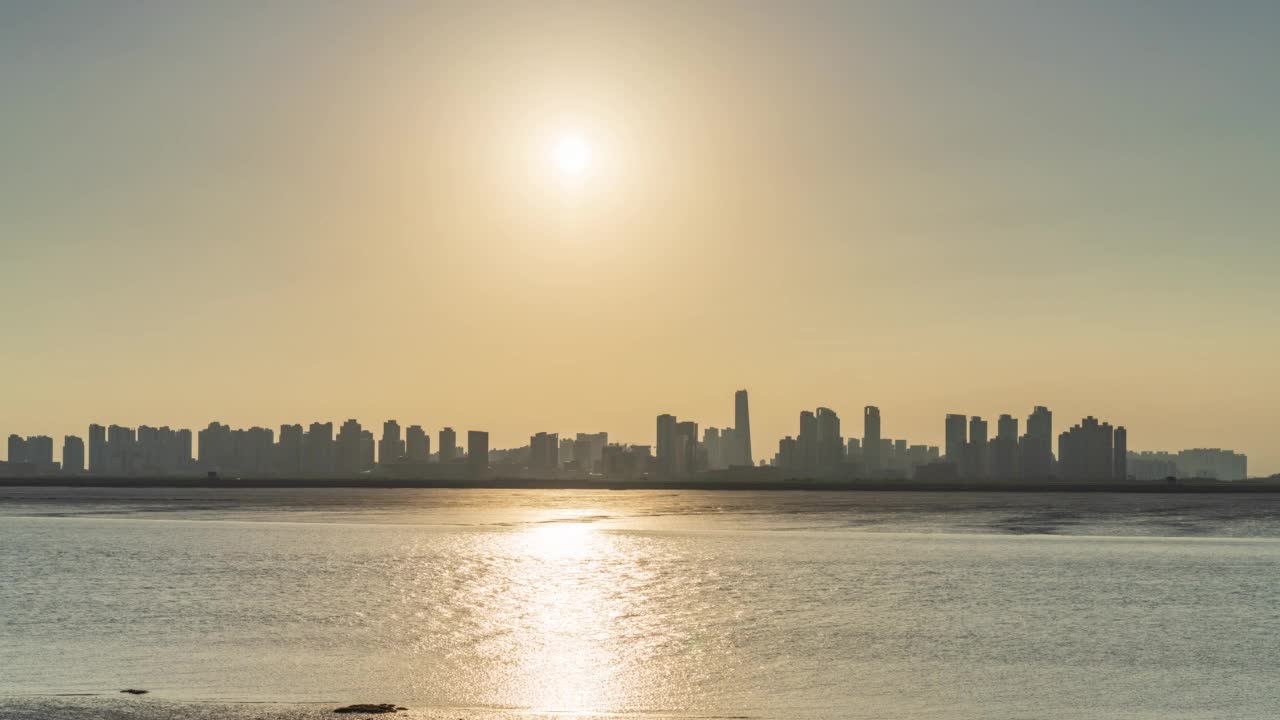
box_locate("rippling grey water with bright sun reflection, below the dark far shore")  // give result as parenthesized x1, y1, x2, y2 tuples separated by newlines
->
(0, 488, 1280, 719)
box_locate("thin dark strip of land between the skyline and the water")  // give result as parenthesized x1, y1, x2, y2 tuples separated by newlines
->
(0, 477, 1280, 493)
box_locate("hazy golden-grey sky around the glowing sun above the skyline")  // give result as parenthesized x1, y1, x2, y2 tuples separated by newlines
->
(0, 0, 1280, 474)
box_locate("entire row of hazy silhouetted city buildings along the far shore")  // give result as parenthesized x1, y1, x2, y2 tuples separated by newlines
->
(0, 389, 1248, 480)
